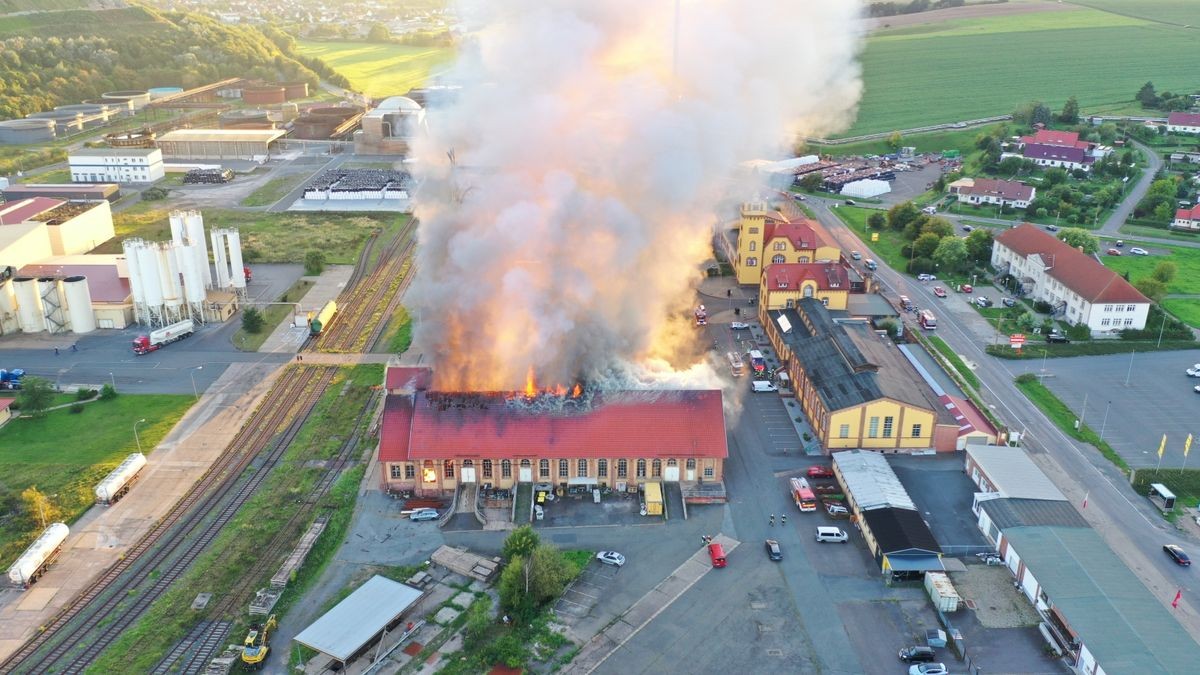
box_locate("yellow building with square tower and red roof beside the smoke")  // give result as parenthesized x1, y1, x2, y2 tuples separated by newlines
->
(733, 202, 841, 286)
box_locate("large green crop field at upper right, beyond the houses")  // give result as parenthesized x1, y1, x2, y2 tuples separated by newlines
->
(846, 0, 1200, 136)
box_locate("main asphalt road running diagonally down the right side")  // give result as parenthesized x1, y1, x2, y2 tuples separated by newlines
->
(808, 193, 1200, 640)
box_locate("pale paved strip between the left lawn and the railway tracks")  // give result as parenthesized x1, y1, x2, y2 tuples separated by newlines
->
(0, 364, 282, 658)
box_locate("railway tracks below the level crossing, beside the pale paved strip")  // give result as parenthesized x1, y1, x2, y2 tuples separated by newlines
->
(0, 366, 336, 673)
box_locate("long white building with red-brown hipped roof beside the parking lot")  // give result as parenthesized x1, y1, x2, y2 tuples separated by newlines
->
(991, 223, 1150, 333)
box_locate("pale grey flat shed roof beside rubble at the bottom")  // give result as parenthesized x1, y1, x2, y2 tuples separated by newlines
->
(295, 574, 421, 663)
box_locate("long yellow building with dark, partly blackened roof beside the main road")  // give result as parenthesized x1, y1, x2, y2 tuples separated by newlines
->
(763, 298, 959, 452)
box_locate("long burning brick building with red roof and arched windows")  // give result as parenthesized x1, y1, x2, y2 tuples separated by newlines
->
(379, 368, 728, 496)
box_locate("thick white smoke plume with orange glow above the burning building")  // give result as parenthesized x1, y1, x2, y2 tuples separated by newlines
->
(413, 0, 862, 390)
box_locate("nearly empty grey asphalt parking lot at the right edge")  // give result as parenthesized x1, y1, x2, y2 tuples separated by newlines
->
(1036, 350, 1200, 468)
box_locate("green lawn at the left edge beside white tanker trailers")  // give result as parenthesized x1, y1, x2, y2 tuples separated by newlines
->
(0, 395, 193, 567)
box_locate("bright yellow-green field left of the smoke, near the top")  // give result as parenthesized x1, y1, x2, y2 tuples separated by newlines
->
(296, 40, 454, 96)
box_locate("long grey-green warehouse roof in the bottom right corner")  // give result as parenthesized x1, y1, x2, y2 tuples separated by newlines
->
(1003, 526, 1200, 673)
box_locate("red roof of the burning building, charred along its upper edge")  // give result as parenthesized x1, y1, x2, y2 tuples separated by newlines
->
(379, 381, 728, 461)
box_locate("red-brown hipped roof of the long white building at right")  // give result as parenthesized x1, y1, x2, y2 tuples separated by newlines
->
(996, 222, 1150, 304)
